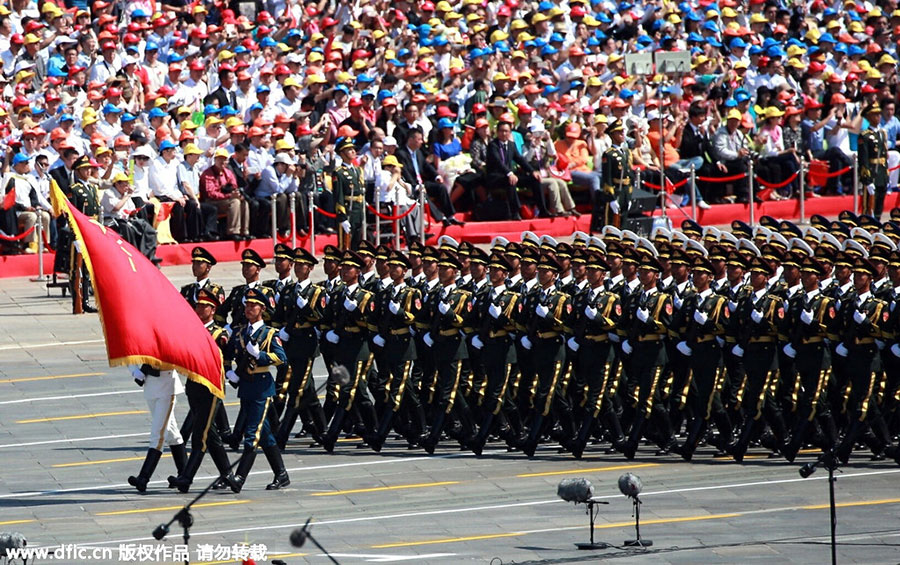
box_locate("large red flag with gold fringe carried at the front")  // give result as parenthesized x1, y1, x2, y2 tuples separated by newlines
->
(51, 182, 225, 398)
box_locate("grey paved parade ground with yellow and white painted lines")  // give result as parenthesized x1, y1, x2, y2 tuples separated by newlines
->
(0, 264, 900, 565)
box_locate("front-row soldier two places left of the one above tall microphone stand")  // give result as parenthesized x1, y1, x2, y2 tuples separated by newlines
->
(675, 257, 731, 461)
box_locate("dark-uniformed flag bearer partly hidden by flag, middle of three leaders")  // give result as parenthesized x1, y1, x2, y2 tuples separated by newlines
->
(169, 283, 231, 492)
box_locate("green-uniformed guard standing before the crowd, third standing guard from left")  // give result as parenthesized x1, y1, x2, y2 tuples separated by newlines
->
(591, 120, 634, 233)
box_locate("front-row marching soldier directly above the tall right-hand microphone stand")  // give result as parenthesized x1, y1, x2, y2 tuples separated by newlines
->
(781, 257, 840, 461)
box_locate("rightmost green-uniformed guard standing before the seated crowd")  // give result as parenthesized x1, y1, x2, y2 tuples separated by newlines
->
(859, 103, 888, 220)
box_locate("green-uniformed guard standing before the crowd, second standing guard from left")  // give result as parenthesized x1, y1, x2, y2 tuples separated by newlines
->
(332, 138, 366, 249)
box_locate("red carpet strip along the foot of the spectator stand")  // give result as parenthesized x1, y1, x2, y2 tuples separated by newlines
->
(0, 192, 900, 278)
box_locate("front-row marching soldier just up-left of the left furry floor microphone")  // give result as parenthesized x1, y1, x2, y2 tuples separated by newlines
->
(520, 253, 575, 457)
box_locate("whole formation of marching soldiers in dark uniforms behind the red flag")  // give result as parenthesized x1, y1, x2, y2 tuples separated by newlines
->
(126, 210, 900, 492)
